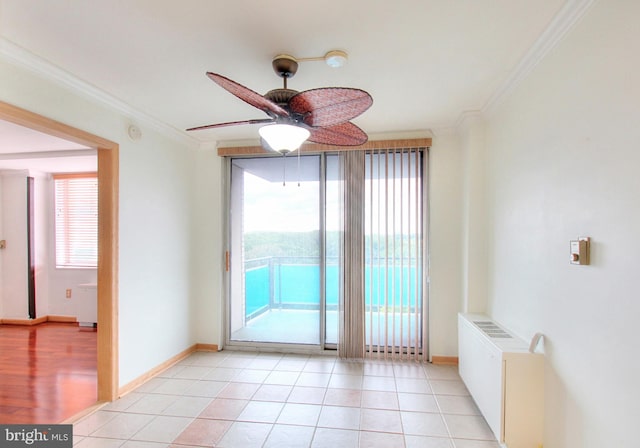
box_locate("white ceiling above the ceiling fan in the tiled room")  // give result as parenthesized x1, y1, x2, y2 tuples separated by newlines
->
(0, 0, 571, 147)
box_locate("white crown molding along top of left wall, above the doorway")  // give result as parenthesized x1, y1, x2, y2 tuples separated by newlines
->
(0, 37, 200, 148)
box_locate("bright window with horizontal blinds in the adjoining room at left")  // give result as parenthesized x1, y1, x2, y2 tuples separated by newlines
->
(53, 173, 98, 268)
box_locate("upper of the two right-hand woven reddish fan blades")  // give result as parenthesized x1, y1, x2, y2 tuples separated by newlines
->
(289, 87, 373, 127)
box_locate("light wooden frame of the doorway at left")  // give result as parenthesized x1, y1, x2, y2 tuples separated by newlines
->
(0, 101, 119, 401)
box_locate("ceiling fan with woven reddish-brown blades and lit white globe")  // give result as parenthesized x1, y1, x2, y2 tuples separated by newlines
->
(187, 53, 373, 154)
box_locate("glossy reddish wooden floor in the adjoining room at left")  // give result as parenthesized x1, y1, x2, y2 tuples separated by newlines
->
(0, 322, 97, 424)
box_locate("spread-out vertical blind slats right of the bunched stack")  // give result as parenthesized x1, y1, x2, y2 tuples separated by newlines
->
(364, 148, 427, 360)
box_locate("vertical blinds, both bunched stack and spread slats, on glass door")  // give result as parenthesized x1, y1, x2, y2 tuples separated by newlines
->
(339, 148, 428, 360)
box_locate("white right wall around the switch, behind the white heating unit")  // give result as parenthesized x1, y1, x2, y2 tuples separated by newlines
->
(487, 0, 640, 448)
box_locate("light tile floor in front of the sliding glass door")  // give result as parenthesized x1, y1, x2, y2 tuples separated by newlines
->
(74, 351, 499, 448)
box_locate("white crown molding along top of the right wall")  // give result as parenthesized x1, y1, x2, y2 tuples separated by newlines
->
(482, 0, 596, 115)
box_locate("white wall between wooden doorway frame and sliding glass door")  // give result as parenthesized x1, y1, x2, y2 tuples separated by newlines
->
(119, 117, 198, 383)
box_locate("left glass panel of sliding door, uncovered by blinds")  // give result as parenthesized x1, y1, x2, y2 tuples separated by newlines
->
(228, 156, 324, 345)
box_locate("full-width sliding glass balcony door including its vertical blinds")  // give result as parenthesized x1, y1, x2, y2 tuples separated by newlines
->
(227, 148, 427, 358)
